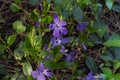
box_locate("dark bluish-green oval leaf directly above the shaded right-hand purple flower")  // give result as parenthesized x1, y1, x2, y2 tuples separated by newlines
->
(72, 5, 83, 22)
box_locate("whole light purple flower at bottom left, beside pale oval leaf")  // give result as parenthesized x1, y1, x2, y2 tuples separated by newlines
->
(31, 62, 53, 80)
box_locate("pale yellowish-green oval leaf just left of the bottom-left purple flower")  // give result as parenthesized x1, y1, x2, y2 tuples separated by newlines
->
(22, 61, 32, 76)
